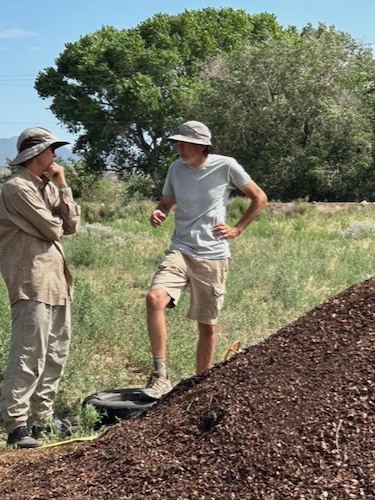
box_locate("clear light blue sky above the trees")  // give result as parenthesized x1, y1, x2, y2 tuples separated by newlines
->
(0, 0, 375, 146)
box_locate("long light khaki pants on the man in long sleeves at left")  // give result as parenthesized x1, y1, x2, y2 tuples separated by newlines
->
(1, 300, 70, 433)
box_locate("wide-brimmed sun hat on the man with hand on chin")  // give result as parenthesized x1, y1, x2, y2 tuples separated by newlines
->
(9, 127, 69, 167)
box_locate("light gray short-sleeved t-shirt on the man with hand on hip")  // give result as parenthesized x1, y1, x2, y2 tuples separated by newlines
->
(163, 154, 251, 259)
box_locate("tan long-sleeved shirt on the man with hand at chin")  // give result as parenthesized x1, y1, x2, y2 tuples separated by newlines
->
(0, 167, 81, 306)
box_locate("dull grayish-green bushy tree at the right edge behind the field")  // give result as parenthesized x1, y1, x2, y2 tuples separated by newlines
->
(196, 25, 375, 201)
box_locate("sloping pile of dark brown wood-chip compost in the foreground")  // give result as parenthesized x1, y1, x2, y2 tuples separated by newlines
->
(0, 278, 375, 500)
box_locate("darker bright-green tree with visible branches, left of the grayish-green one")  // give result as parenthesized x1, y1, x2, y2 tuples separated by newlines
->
(35, 8, 283, 188)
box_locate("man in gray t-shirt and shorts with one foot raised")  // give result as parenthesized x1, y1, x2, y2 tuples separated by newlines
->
(141, 121, 267, 400)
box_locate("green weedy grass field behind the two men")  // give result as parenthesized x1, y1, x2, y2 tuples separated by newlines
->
(0, 199, 375, 442)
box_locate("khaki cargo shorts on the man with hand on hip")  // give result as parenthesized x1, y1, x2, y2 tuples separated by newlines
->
(150, 250, 230, 325)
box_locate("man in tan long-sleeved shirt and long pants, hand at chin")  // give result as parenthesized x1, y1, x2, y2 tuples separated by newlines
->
(0, 127, 80, 448)
